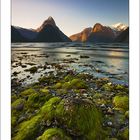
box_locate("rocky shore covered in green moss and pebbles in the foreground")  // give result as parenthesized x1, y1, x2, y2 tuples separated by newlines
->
(11, 67, 129, 140)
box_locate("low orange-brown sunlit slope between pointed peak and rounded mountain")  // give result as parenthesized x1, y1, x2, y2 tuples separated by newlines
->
(69, 27, 92, 42)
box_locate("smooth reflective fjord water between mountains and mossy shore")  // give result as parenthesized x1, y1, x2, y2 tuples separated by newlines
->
(11, 42, 129, 85)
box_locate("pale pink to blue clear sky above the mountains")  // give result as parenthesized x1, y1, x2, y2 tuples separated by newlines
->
(12, 0, 129, 36)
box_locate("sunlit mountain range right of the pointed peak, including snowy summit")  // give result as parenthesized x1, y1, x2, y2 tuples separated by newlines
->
(70, 23, 127, 43)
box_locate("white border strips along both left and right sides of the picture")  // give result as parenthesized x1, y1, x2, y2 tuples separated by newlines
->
(0, 0, 140, 140)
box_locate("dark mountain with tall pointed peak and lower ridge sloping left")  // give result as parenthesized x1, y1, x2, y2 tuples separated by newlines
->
(11, 17, 71, 42)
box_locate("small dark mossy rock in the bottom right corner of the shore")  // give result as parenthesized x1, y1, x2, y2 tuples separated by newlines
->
(118, 127, 129, 140)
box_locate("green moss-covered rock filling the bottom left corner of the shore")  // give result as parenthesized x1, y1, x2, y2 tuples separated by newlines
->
(12, 116, 41, 140)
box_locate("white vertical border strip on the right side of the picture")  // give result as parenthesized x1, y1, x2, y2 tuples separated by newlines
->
(129, 0, 140, 140)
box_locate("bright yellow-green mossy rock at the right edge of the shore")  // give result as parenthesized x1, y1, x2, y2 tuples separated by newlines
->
(113, 96, 129, 111)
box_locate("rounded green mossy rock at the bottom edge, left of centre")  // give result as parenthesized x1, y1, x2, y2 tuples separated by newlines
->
(37, 128, 72, 140)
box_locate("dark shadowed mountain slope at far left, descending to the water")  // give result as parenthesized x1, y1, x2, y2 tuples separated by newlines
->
(11, 26, 29, 42)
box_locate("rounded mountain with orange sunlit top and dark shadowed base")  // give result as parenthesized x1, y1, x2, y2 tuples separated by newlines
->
(87, 23, 116, 43)
